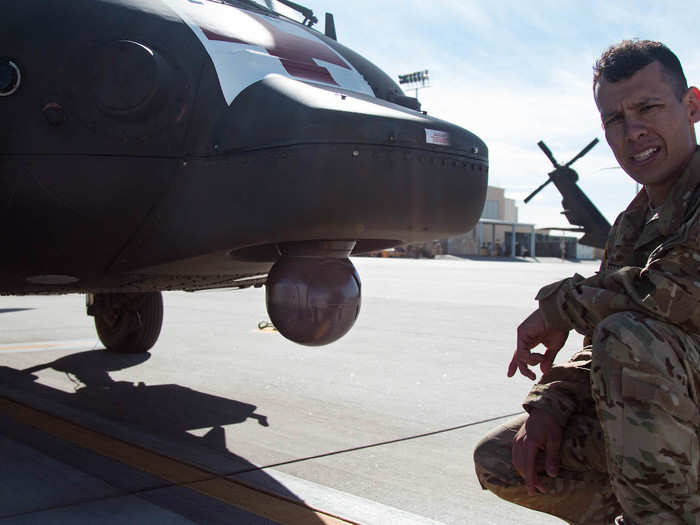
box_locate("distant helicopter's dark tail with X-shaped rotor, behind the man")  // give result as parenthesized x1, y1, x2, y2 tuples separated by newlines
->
(525, 138, 610, 248)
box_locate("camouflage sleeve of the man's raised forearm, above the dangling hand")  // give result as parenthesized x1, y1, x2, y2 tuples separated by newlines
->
(536, 210, 700, 336)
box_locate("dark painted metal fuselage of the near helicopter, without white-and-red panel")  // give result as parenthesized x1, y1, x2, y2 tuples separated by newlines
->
(0, 0, 488, 293)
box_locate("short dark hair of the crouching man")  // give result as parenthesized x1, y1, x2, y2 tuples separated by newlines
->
(593, 38, 688, 99)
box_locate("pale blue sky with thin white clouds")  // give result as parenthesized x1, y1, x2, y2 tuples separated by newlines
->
(276, 0, 700, 227)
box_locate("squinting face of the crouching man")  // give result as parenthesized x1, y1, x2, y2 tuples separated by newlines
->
(595, 62, 700, 205)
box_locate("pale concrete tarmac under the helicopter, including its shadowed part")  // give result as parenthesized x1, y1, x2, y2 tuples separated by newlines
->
(0, 257, 597, 525)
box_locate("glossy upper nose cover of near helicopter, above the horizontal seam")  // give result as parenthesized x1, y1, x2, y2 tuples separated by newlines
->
(208, 75, 487, 161)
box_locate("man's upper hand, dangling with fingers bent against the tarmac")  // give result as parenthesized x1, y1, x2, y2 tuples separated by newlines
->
(508, 309, 569, 379)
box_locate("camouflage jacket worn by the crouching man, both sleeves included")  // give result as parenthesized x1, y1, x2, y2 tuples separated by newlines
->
(523, 147, 700, 425)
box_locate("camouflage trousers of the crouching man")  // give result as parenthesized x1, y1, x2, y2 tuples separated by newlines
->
(474, 312, 700, 525)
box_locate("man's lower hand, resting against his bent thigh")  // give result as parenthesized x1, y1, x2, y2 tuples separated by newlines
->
(512, 410, 562, 496)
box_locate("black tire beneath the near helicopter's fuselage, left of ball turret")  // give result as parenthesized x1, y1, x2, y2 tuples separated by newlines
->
(95, 292, 163, 354)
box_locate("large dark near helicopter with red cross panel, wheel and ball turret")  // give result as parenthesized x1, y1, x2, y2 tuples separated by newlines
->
(0, 0, 488, 352)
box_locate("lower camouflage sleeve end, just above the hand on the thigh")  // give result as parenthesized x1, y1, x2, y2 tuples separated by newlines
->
(523, 349, 594, 427)
